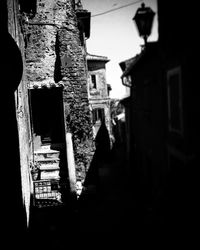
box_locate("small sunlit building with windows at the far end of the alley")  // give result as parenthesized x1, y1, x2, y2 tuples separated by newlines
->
(87, 54, 111, 137)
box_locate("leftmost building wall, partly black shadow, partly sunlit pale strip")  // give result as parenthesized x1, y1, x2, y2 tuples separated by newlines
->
(0, 0, 33, 242)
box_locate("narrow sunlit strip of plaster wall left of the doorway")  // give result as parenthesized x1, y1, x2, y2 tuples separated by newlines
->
(7, 0, 31, 224)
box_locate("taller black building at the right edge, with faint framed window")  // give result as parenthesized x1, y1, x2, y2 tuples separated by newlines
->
(158, 0, 199, 227)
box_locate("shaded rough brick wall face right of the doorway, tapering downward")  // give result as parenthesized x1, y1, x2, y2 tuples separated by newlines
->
(58, 1, 93, 179)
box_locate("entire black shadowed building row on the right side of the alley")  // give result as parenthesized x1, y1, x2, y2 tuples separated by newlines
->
(122, 1, 199, 229)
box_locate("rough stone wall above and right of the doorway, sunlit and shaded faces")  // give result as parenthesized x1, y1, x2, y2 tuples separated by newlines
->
(24, 0, 92, 183)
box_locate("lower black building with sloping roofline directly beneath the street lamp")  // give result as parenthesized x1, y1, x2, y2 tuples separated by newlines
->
(122, 42, 167, 210)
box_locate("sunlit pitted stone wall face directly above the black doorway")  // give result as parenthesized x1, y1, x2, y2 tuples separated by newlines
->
(24, 1, 57, 86)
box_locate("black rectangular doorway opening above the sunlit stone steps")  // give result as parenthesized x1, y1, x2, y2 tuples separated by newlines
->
(30, 88, 65, 145)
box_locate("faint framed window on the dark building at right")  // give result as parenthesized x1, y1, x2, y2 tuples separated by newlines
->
(167, 67, 183, 134)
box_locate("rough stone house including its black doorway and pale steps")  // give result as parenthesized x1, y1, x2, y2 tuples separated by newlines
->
(21, 0, 92, 202)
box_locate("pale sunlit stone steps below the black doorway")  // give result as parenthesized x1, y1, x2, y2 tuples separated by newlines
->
(34, 145, 60, 180)
